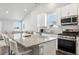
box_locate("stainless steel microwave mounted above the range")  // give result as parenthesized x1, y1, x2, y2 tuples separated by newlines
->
(61, 16, 78, 25)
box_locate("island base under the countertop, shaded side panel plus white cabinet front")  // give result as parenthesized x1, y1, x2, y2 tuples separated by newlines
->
(32, 39, 56, 55)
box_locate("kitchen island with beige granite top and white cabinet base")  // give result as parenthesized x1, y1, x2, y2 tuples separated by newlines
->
(14, 35, 57, 55)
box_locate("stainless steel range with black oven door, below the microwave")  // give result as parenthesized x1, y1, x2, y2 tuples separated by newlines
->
(58, 29, 79, 54)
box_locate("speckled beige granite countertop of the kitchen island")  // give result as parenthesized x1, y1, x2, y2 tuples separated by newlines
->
(15, 35, 56, 47)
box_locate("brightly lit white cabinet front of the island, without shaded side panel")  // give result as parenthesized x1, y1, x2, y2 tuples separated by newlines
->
(39, 40, 56, 55)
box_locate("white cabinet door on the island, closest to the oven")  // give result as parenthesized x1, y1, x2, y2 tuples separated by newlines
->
(43, 40, 56, 55)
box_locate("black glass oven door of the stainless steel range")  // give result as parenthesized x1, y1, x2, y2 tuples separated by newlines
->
(58, 39, 76, 54)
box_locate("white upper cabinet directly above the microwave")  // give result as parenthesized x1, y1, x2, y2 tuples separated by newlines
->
(61, 3, 78, 17)
